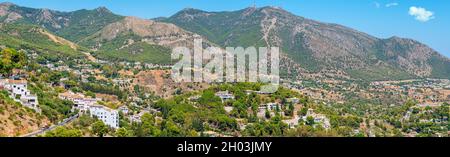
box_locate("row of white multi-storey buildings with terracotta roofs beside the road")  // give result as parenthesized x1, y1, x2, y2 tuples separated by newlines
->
(59, 92, 119, 128)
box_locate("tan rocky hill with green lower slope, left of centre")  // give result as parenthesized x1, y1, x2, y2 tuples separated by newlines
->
(79, 17, 209, 64)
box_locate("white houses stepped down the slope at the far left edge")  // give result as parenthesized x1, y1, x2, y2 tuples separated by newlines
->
(0, 79, 41, 112)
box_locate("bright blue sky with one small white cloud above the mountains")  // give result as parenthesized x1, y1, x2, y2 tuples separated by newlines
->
(0, 0, 450, 57)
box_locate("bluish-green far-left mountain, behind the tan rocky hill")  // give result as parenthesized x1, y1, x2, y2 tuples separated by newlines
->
(0, 2, 124, 41)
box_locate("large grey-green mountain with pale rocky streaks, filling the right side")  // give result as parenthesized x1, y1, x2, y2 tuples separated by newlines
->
(162, 7, 450, 80)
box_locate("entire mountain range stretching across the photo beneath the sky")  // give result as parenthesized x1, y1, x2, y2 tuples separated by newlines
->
(0, 3, 450, 80)
